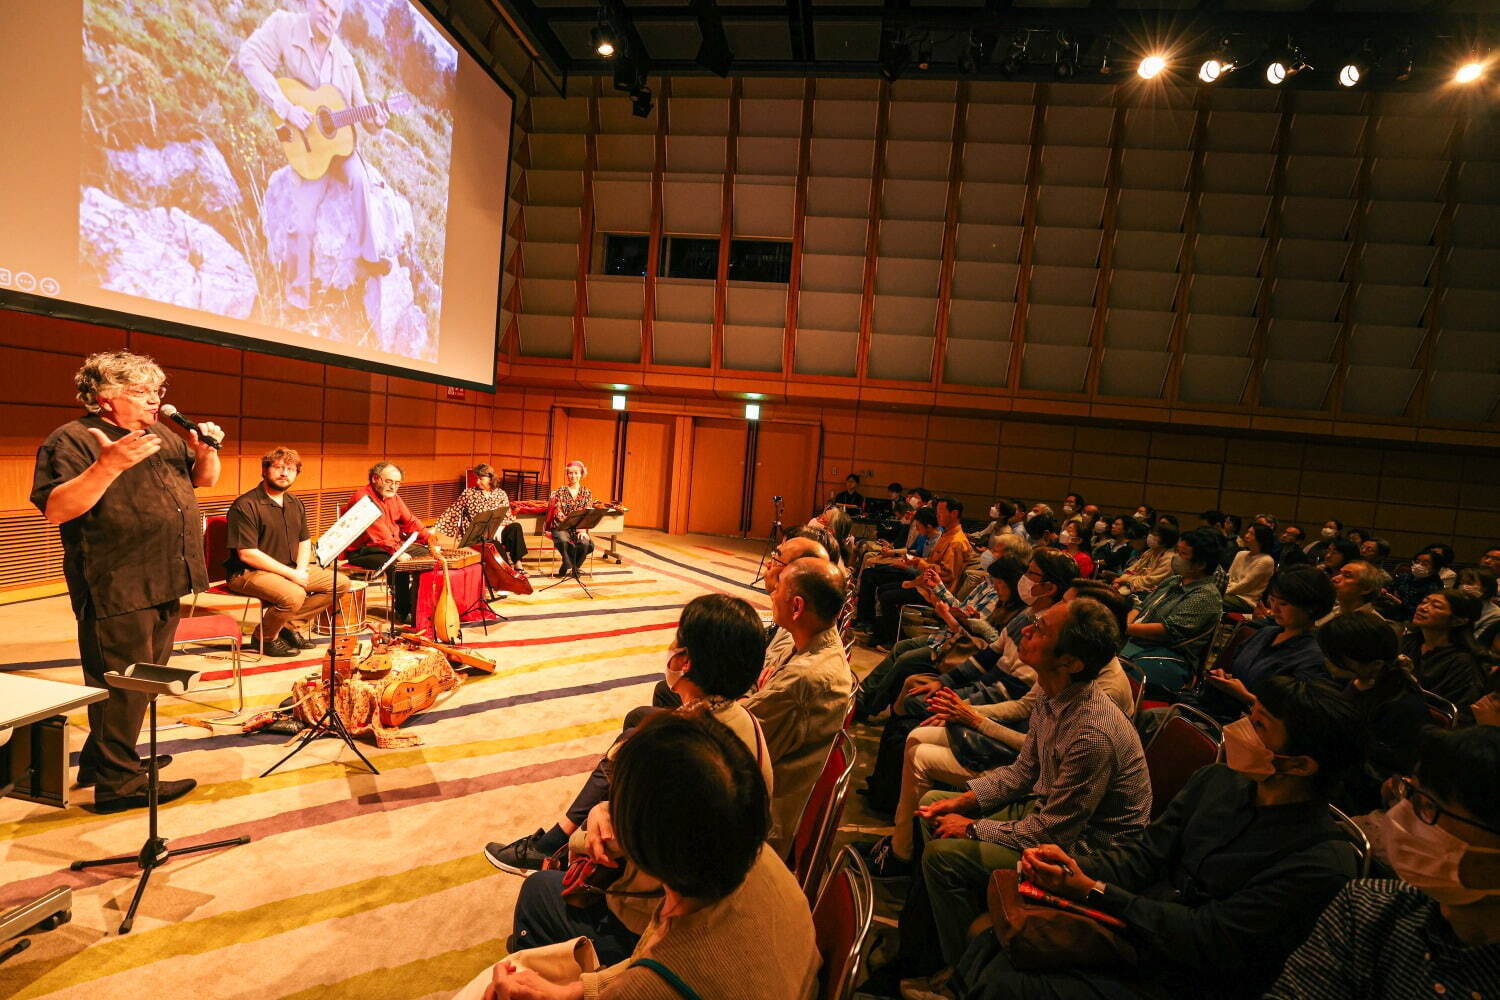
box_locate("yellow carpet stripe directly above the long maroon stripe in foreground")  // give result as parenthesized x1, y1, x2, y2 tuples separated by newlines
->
(0, 717, 626, 841)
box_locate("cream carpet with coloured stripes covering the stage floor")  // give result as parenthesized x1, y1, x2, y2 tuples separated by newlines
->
(0, 531, 792, 1000)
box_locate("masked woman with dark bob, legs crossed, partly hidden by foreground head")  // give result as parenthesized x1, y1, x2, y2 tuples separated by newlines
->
(485, 594, 774, 963)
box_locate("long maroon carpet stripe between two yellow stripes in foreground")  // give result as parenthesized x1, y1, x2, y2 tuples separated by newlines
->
(0, 754, 599, 910)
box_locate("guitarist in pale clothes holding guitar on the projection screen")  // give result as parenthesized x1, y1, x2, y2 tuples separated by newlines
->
(236, 0, 405, 309)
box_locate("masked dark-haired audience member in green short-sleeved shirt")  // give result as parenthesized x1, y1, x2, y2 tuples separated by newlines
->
(1122, 525, 1224, 697)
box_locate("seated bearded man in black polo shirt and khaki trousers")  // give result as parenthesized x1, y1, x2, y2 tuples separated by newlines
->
(224, 448, 350, 657)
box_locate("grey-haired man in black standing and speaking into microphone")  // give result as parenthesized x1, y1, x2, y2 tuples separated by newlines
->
(32, 351, 224, 813)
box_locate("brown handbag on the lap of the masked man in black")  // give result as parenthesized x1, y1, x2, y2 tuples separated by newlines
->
(987, 868, 1140, 972)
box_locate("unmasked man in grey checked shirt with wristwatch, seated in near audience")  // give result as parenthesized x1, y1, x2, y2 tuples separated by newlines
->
(878, 600, 1151, 982)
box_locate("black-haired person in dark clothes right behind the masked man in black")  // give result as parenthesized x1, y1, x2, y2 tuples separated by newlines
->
(1317, 615, 1428, 816)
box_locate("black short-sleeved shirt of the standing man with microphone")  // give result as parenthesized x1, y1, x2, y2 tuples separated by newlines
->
(32, 414, 209, 618)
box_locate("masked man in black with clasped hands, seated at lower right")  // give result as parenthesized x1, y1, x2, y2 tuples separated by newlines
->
(953, 678, 1374, 1000)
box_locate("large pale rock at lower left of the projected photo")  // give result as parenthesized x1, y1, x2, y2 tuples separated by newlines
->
(78, 187, 257, 319)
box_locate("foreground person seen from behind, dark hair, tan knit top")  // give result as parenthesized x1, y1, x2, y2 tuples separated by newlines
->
(480, 714, 821, 1000)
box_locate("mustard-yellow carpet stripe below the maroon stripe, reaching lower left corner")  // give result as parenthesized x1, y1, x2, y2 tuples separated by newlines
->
(11, 855, 500, 1000)
